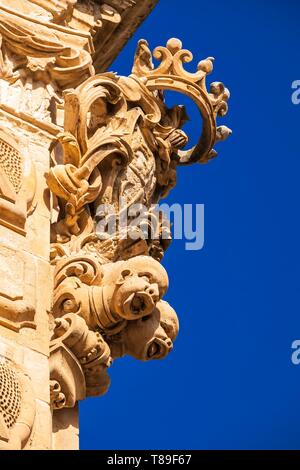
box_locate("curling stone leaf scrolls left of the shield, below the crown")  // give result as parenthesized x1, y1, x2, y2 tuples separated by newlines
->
(47, 78, 132, 239)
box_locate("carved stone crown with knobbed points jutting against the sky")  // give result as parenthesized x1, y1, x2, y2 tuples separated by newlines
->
(132, 38, 231, 165)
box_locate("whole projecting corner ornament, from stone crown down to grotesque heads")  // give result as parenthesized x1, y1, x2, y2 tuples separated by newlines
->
(47, 39, 231, 408)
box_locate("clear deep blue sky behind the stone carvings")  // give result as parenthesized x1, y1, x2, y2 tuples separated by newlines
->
(80, 0, 300, 449)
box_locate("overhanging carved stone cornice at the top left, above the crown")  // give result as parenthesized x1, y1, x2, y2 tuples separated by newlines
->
(0, 0, 157, 124)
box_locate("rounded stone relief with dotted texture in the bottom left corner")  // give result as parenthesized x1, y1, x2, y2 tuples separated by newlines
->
(0, 362, 35, 450)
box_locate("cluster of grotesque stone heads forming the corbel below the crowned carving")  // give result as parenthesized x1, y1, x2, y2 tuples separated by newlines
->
(50, 256, 178, 409)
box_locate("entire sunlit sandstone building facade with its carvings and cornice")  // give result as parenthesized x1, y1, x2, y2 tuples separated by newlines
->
(0, 0, 230, 450)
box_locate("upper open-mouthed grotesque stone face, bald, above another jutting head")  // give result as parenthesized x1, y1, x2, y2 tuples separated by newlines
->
(112, 256, 168, 320)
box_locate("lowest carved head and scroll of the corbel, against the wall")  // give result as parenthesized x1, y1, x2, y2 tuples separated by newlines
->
(50, 314, 111, 409)
